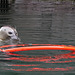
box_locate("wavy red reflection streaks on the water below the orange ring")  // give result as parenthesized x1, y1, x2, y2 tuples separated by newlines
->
(1, 52, 75, 71)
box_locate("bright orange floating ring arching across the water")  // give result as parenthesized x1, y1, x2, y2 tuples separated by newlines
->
(0, 44, 75, 52)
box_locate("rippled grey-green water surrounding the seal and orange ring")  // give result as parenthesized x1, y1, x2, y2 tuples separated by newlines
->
(0, 0, 75, 75)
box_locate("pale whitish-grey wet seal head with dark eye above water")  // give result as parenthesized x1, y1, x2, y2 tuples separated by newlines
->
(0, 26, 20, 42)
